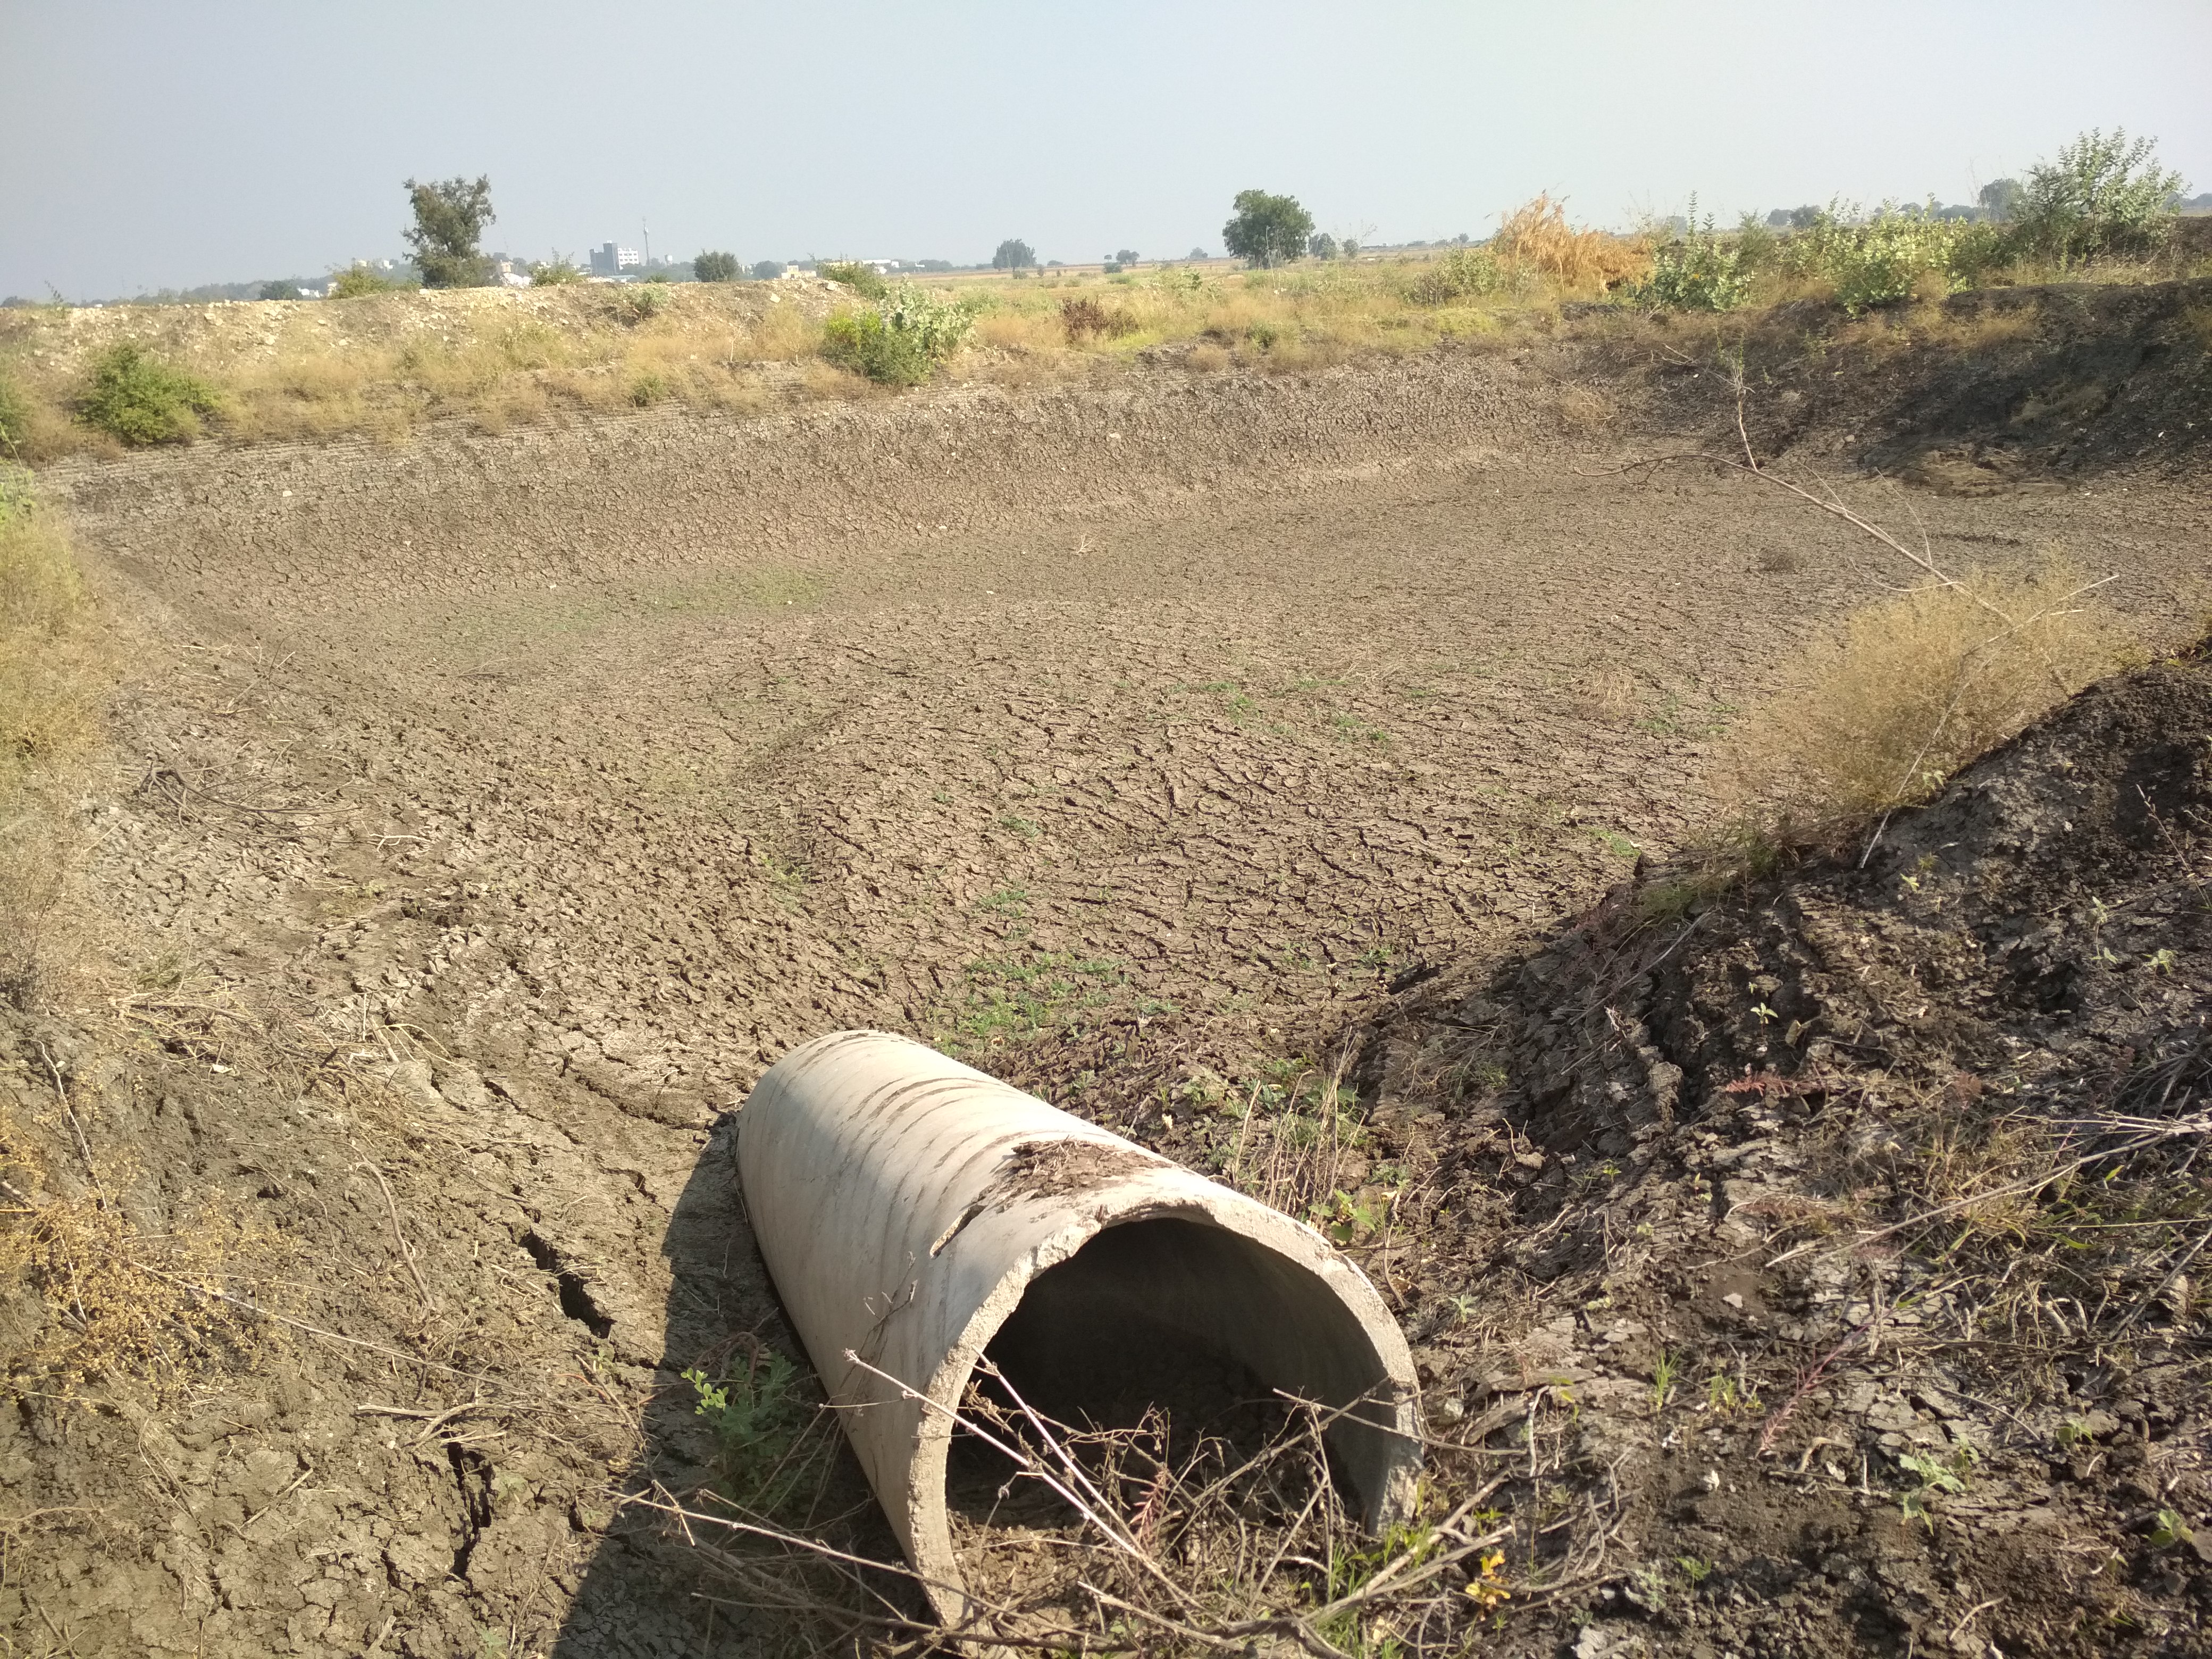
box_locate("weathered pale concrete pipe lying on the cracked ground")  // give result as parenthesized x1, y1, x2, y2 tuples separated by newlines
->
(736, 1031, 1420, 1621)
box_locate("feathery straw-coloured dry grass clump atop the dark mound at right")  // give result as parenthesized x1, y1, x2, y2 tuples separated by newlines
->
(1734, 559, 2126, 825)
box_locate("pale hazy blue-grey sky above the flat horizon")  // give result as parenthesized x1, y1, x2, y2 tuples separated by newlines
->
(0, 0, 2212, 299)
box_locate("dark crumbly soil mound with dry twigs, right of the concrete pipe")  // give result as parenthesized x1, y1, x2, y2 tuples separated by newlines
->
(1356, 652, 2212, 1655)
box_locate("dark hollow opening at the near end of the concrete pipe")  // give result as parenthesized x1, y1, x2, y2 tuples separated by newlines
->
(944, 1217, 1396, 1531)
